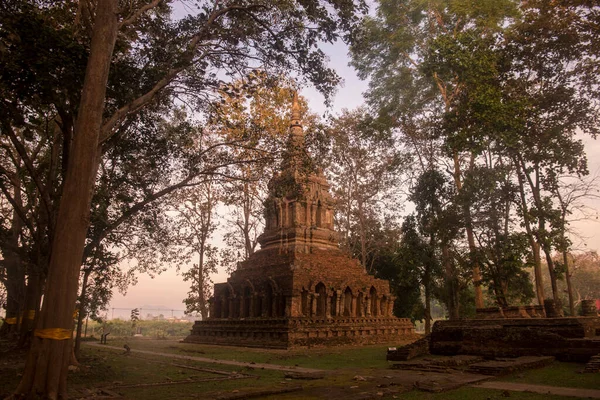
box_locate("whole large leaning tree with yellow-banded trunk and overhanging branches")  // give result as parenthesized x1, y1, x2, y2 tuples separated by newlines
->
(2, 0, 362, 398)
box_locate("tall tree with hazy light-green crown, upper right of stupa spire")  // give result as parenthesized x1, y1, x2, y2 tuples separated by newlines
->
(352, 0, 515, 307)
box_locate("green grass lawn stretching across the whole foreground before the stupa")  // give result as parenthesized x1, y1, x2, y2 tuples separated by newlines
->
(0, 339, 600, 400)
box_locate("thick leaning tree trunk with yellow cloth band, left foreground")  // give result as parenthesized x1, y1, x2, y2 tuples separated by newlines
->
(17, 0, 118, 399)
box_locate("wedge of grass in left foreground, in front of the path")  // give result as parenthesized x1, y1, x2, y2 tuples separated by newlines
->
(0, 347, 284, 400)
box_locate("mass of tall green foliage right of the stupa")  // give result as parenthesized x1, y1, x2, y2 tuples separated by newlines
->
(351, 0, 599, 312)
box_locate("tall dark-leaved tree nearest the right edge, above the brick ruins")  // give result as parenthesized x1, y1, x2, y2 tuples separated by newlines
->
(496, 1, 598, 309)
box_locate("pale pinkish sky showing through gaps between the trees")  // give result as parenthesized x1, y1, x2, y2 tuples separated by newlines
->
(108, 34, 600, 319)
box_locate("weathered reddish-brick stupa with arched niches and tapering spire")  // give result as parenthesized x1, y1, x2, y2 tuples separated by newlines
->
(185, 95, 414, 348)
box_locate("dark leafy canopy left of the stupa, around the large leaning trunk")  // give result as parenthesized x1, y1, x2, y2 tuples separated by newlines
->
(0, 0, 366, 344)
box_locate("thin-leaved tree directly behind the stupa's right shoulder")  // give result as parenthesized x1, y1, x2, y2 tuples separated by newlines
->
(327, 109, 406, 273)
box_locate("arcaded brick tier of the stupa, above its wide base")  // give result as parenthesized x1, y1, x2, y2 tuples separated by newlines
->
(212, 249, 394, 318)
